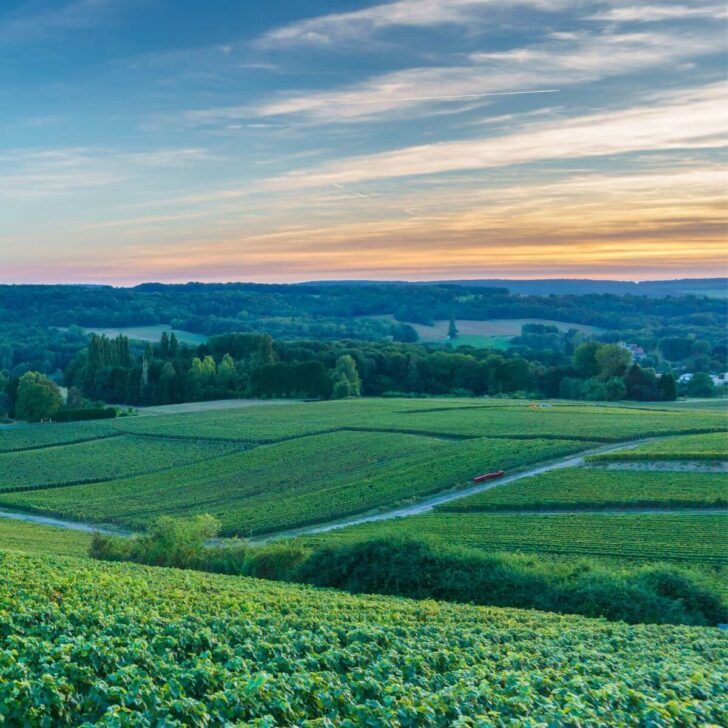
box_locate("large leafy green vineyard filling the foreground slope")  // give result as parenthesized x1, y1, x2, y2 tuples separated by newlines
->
(0, 553, 728, 728)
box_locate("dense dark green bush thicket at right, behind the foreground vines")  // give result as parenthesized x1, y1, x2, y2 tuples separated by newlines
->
(295, 539, 725, 625)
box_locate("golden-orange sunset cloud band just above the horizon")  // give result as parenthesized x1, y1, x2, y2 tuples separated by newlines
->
(31, 167, 728, 280)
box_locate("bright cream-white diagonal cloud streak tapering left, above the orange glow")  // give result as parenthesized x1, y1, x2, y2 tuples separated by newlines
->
(267, 83, 728, 189)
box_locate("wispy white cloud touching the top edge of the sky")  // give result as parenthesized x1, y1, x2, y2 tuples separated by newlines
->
(258, 0, 568, 48)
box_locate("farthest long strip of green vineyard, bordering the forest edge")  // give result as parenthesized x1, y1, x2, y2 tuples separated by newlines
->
(109, 399, 726, 443)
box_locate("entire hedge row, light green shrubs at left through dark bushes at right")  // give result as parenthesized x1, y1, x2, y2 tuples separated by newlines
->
(89, 516, 726, 625)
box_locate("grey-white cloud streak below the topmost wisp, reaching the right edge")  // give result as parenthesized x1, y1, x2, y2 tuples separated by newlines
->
(216, 27, 725, 124)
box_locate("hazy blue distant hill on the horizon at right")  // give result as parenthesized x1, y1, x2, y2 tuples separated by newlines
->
(430, 278, 728, 298)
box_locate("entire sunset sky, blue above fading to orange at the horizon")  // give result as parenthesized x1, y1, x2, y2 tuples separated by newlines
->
(0, 0, 728, 285)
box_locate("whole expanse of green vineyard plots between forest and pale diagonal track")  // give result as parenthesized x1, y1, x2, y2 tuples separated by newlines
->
(0, 399, 725, 536)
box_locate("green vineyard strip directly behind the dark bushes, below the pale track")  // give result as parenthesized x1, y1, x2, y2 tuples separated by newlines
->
(303, 513, 728, 566)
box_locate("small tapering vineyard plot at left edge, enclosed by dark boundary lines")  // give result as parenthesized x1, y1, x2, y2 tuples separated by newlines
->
(0, 436, 234, 493)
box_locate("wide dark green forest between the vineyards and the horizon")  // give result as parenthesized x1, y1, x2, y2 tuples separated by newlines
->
(0, 283, 728, 419)
